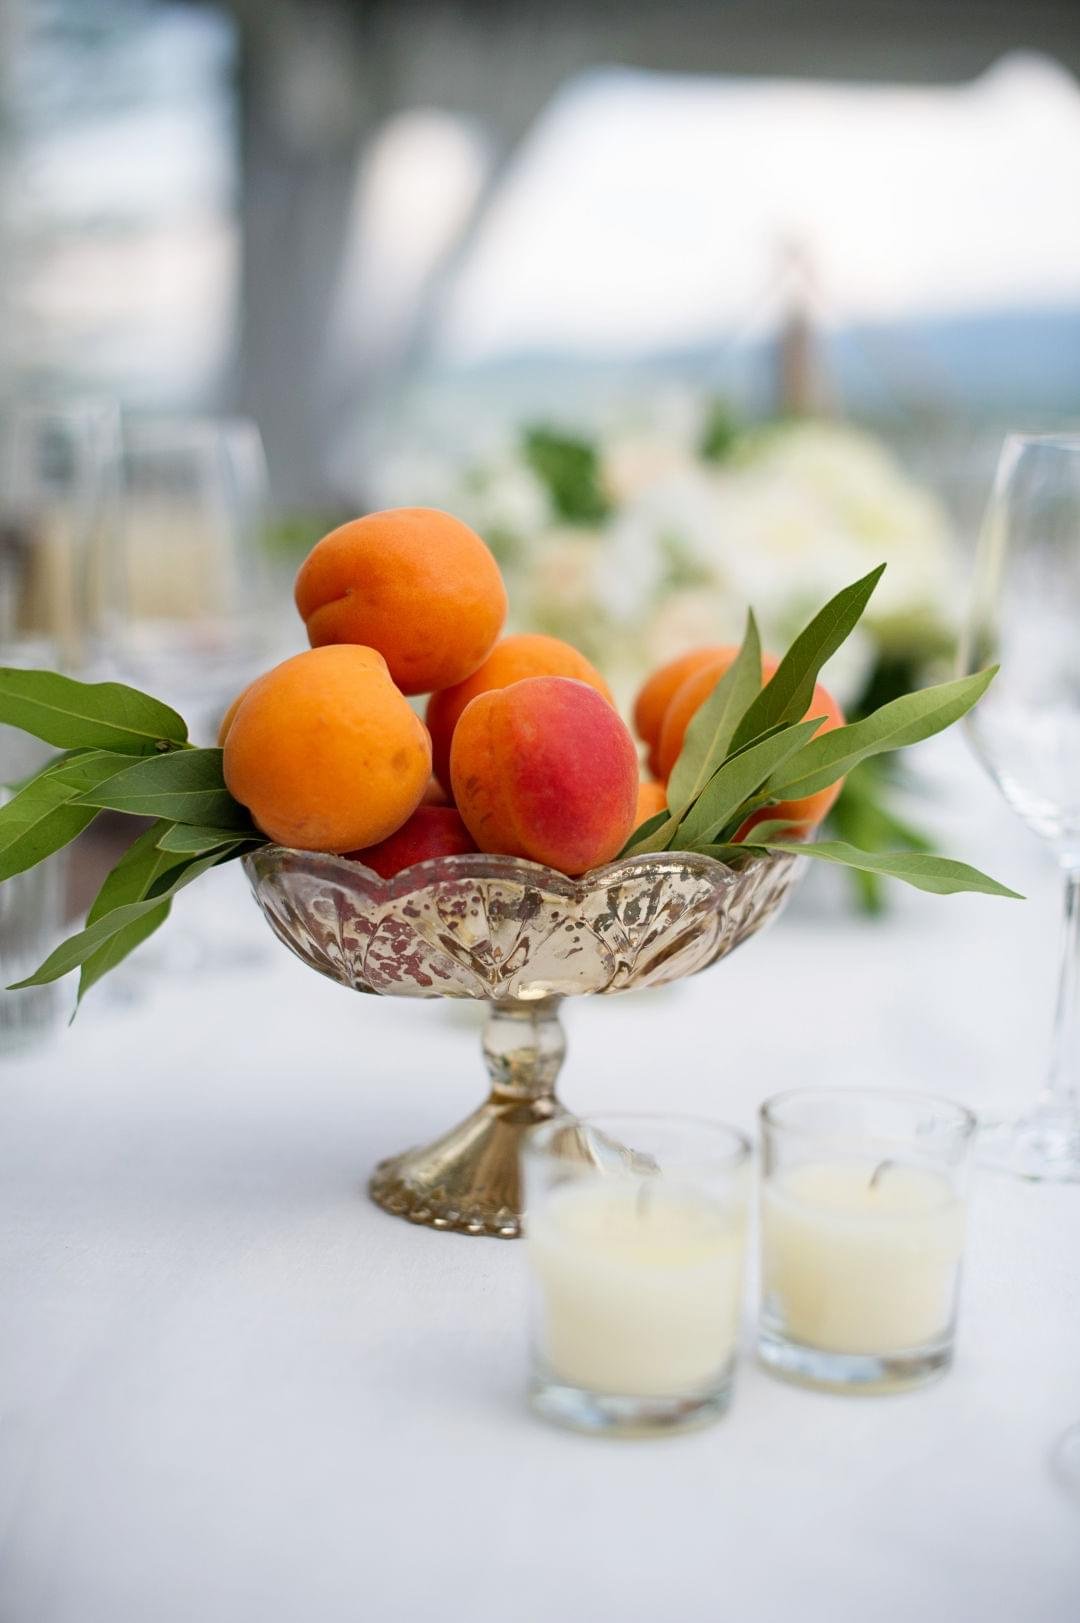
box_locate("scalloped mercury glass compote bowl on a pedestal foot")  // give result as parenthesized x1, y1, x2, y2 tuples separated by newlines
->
(244, 846, 802, 1238)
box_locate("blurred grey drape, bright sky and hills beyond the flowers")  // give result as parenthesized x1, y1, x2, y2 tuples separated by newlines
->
(0, 0, 1080, 496)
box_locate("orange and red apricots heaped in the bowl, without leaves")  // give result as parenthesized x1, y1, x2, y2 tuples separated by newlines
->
(219, 508, 843, 876)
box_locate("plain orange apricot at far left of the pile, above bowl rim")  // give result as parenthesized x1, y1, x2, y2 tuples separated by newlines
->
(224, 644, 432, 850)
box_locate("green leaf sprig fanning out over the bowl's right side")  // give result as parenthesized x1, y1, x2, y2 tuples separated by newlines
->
(622, 565, 1017, 896)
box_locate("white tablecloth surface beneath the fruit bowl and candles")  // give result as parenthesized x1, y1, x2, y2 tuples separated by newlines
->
(0, 743, 1080, 1623)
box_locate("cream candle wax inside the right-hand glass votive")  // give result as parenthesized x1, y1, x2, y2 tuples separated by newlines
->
(762, 1160, 965, 1354)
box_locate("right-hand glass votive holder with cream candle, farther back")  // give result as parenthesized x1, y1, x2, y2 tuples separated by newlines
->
(758, 1087, 976, 1393)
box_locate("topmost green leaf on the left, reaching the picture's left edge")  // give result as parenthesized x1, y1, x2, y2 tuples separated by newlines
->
(0, 665, 187, 755)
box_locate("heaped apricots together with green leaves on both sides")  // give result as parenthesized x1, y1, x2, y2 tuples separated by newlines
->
(0, 508, 1015, 998)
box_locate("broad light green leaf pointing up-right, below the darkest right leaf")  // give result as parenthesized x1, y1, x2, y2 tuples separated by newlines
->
(768, 665, 997, 800)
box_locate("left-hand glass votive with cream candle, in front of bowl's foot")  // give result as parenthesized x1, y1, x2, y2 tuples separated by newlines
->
(523, 1115, 750, 1435)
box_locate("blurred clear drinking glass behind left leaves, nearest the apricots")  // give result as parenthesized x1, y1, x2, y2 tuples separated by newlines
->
(102, 417, 271, 743)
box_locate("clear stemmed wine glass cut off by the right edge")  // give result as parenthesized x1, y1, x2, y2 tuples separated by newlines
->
(960, 433, 1080, 1182)
